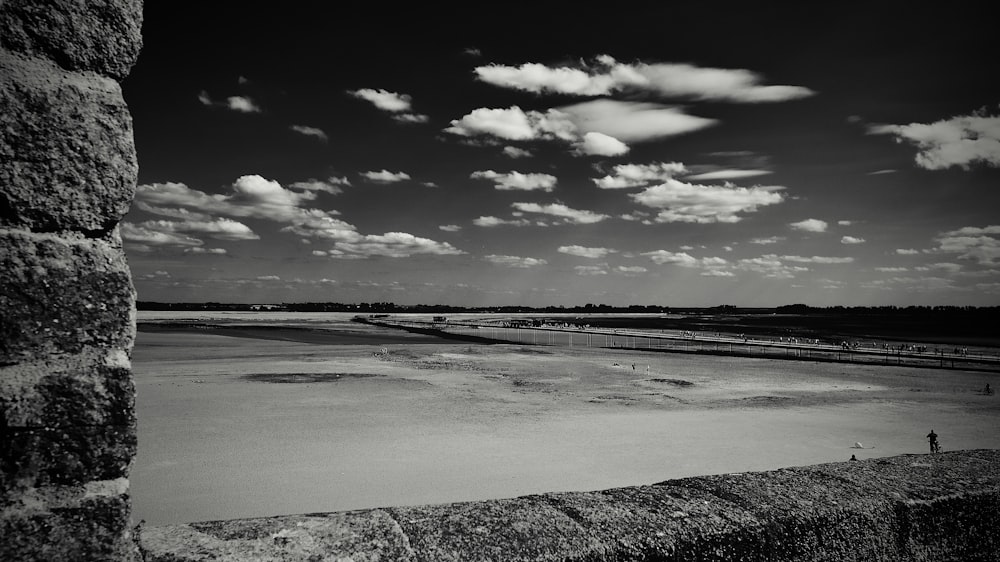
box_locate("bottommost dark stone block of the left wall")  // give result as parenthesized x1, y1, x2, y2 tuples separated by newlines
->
(0, 495, 139, 562)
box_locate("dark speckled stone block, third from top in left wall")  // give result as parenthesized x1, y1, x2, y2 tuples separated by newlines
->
(0, 229, 135, 366)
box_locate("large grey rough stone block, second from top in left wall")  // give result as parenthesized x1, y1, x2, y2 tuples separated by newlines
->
(0, 48, 138, 233)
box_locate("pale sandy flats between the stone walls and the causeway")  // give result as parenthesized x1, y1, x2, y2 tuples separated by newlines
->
(131, 318, 1000, 525)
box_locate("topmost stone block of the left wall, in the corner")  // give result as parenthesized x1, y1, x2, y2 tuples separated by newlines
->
(0, 0, 142, 79)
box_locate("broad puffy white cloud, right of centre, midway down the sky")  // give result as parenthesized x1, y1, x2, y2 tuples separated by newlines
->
(629, 179, 784, 223)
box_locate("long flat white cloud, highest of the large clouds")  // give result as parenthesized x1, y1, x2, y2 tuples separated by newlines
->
(475, 55, 815, 103)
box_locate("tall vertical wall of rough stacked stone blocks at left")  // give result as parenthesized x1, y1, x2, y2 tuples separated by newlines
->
(0, 0, 142, 561)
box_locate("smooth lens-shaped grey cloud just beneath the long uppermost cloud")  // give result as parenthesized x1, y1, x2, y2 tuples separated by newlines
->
(550, 99, 717, 143)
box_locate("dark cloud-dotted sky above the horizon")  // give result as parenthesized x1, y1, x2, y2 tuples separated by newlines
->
(120, 1, 1000, 307)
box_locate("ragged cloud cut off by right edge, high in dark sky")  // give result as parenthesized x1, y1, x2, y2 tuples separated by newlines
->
(868, 108, 1000, 170)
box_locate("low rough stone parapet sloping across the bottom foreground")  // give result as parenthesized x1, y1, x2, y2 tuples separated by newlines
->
(141, 450, 1000, 562)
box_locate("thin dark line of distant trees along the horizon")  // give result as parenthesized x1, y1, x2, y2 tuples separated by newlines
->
(136, 301, 1000, 318)
